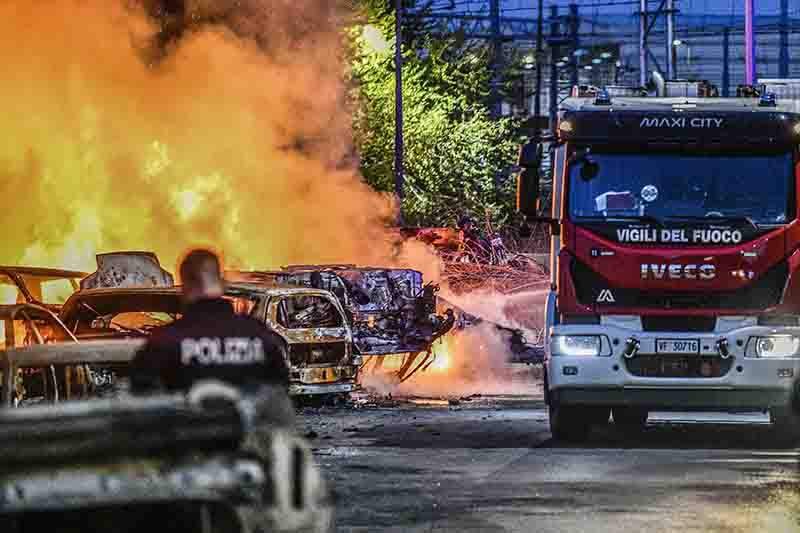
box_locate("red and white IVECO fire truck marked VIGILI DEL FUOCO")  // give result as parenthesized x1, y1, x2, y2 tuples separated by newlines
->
(517, 81, 800, 441)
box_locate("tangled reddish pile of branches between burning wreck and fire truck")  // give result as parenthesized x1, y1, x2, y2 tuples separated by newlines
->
(442, 255, 550, 294)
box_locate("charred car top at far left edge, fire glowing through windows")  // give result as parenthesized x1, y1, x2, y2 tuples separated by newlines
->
(0, 266, 86, 310)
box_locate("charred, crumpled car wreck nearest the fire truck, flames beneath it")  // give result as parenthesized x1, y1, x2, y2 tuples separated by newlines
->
(226, 265, 454, 356)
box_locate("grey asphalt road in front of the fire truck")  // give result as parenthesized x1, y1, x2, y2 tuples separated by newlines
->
(301, 394, 800, 533)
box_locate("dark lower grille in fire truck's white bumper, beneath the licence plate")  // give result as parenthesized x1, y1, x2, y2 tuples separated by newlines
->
(625, 354, 733, 379)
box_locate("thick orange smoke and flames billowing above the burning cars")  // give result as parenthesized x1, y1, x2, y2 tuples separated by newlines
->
(0, 0, 435, 275)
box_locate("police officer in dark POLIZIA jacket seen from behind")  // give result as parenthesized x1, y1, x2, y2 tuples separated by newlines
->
(131, 250, 288, 392)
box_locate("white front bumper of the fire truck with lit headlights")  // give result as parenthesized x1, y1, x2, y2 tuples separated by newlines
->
(546, 317, 800, 410)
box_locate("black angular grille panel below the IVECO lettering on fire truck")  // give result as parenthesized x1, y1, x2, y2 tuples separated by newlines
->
(571, 260, 789, 310)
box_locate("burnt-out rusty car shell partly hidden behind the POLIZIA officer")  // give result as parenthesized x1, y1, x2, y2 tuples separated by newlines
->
(61, 283, 360, 395)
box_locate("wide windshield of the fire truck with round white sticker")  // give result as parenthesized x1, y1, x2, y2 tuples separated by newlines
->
(569, 152, 795, 225)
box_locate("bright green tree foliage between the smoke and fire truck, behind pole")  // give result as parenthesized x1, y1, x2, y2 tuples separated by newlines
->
(349, 0, 518, 225)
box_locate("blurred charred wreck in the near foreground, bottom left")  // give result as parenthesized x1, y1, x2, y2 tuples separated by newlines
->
(0, 356, 333, 533)
